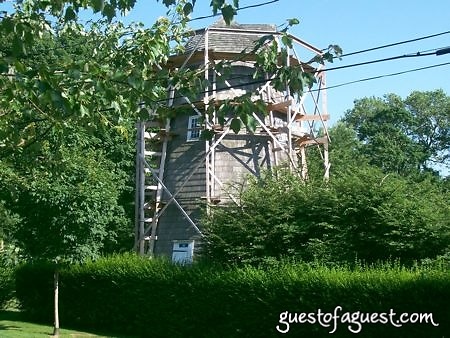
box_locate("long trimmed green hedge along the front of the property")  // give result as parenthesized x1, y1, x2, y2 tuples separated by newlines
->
(16, 256, 450, 337)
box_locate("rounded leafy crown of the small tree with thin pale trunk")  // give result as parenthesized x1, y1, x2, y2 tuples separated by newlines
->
(0, 147, 127, 261)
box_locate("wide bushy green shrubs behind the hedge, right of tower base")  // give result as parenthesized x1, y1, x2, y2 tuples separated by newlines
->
(202, 163, 450, 264)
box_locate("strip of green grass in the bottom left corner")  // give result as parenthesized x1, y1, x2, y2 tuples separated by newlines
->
(0, 310, 132, 338)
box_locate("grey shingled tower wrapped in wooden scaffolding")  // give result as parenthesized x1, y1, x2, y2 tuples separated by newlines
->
(135, 22, 329, 261)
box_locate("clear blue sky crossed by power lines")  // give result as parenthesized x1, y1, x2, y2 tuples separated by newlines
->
(0, 0, 450, 124)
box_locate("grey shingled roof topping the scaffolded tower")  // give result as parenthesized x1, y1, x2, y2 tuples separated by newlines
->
(186, 19, 277, 53)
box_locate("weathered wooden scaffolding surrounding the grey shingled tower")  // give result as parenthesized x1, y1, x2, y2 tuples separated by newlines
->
(135, 24, 330, 256)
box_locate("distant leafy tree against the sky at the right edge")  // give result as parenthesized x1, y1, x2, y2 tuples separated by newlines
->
(343, 90, 450, 175)
